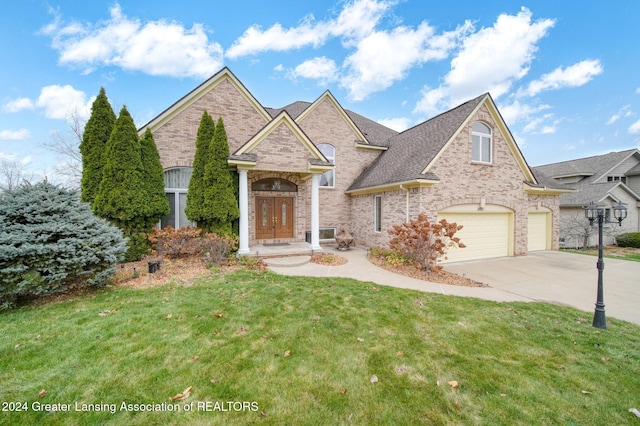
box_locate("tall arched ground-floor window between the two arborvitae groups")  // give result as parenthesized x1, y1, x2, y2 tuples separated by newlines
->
(160, 167, 195, 229)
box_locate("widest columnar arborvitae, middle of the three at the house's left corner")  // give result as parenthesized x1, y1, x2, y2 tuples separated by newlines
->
(93, 107, 148, 261)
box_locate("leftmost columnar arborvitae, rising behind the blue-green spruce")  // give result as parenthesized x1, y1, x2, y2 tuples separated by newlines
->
(80, 87, 116, 205)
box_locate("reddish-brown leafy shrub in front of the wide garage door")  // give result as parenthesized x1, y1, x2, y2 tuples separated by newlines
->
(387, 213, 465, 272)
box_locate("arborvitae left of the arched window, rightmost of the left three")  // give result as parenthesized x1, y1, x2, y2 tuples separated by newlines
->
(140, 129, 169, 228)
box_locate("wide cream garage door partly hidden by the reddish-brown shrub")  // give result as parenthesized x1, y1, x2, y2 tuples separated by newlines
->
(438, 212, 512, 263)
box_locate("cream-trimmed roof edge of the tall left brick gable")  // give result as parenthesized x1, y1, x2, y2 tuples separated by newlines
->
(138, 67, 272, 134)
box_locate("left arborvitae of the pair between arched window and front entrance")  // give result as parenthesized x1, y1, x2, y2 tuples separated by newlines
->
(184, 111, 216, 226)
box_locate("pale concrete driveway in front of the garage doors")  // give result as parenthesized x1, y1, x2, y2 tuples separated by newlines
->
(445, 251, 640, 324)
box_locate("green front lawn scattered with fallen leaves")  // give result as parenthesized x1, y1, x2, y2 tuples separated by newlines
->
(0, 271, 640, 425)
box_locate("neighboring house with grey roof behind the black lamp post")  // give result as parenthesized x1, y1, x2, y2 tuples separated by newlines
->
(534, 149, 640, 247)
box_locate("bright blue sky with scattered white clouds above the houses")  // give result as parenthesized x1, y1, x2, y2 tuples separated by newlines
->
(0, 0, 640, 185)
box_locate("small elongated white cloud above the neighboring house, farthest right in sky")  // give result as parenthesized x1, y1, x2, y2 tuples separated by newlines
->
(526, 59, 604, 96)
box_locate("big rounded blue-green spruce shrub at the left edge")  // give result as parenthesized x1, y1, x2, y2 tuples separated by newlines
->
(0, 182, 127, 309)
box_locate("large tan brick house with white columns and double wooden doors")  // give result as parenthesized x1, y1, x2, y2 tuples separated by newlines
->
(140, 68, 566, 261)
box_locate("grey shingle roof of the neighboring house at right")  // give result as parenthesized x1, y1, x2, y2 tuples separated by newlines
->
(534, 149, 640, 207)
